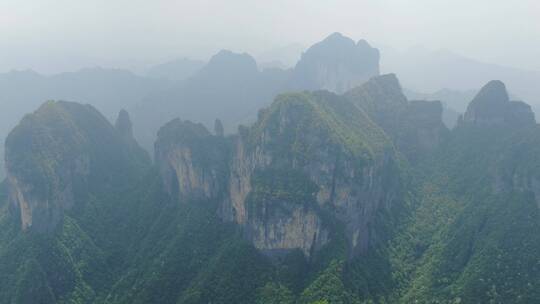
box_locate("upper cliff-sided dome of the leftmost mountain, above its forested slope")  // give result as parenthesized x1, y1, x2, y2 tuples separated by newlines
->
(5, 101, 144, 232)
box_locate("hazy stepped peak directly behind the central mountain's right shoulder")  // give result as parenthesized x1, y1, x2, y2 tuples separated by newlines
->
(345, 74, 448, 161)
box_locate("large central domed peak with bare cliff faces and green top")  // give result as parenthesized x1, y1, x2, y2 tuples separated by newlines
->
(242, 92, 400, 255)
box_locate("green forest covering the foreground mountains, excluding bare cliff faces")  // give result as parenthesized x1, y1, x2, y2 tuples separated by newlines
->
(0, 88, 540, 304)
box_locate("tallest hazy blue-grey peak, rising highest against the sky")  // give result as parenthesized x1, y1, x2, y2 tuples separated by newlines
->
(292, 33, 379, 93)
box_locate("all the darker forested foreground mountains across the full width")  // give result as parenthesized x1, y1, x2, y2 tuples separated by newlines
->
(0, 57, 540, 304)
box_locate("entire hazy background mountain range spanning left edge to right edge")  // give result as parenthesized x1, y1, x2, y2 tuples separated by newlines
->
(4, 33, 540, 177)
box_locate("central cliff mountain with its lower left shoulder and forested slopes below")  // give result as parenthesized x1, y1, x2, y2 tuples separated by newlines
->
(123, 92, 406, 303)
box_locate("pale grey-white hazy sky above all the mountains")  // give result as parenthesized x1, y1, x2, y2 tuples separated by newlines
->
(0, 0, 540, 73)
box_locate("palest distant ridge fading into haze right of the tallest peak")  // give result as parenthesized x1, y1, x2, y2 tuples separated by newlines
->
(381, 47, 540, 113)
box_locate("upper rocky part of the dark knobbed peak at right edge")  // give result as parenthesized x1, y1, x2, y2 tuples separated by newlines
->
(458, 80, 540, 206)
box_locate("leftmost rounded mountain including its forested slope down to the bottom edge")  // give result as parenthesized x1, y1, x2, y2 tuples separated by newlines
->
(0, 101, 149, 303)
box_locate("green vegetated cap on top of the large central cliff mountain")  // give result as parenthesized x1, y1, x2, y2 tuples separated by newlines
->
(249, 92, 391, 163)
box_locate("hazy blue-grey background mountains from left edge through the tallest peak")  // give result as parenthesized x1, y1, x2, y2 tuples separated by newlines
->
(0, 33, 379, 189)
